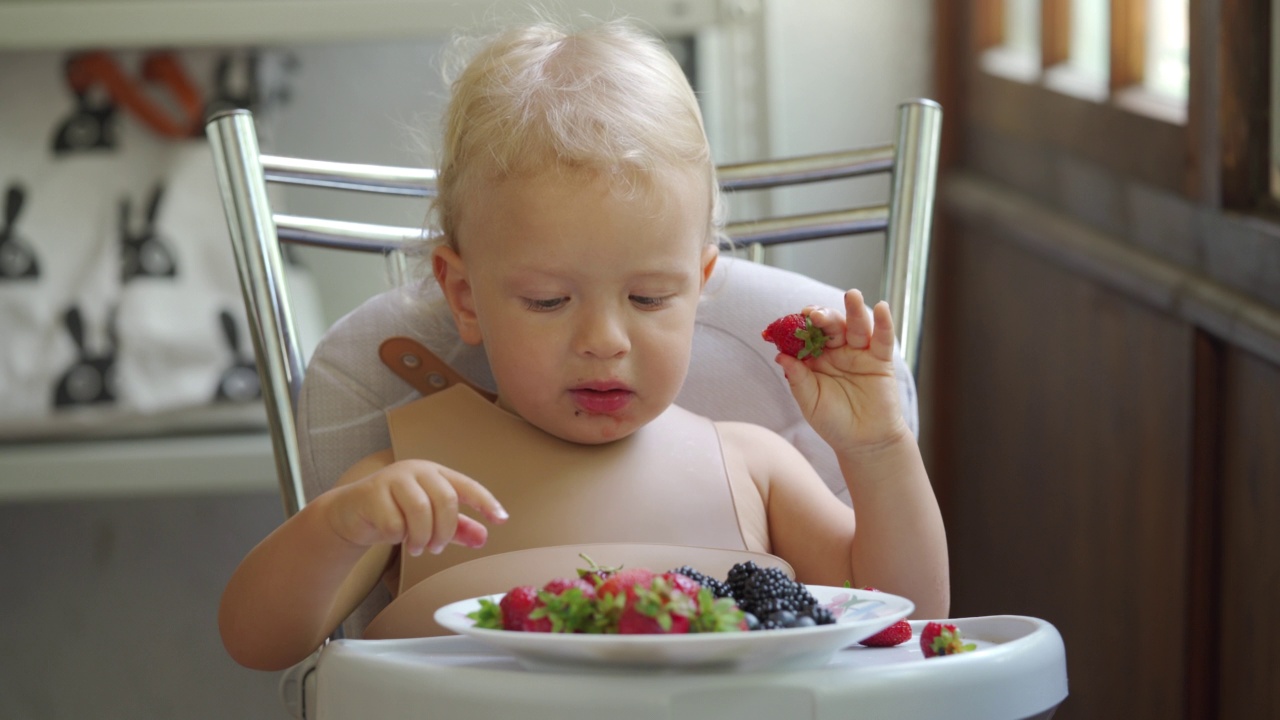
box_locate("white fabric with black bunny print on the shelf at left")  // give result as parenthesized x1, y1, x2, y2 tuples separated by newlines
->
(0, 50, 309, 439)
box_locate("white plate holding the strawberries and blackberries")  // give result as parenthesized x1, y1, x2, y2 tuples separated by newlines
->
(435, 585, 915, 673)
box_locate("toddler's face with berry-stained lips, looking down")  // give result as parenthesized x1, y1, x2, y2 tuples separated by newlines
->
(434, 166, 717, 443)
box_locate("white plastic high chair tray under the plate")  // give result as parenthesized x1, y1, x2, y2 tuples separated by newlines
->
(316, 615, 1068, 720)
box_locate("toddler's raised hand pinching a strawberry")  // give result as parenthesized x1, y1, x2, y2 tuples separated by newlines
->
(776, 290, 910, 454)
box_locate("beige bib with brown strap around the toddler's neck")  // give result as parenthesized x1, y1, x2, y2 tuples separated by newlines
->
(364, 384, 790, 638)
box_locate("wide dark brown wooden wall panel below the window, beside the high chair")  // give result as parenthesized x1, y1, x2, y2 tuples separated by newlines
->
(929, 225, 1193, 720)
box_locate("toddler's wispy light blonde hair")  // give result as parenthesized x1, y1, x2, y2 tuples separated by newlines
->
(431, 20, 721, 249)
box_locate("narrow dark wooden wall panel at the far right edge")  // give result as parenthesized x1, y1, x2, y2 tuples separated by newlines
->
(1219, 348, 1280, 720)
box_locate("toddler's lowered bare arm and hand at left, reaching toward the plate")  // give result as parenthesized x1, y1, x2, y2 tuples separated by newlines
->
(218, 451, 506, 670)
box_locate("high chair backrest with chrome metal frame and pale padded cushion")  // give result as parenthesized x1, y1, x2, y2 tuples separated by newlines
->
(206, 100, 942, 515)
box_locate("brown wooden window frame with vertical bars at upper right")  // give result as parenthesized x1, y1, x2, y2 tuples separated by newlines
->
(962, 0, 1228, 202)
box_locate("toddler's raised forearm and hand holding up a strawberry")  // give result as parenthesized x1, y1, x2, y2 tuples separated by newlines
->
(771, 290, 951, 618)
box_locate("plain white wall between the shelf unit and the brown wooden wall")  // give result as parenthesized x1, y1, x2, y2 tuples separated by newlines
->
(764, 0, 933, 297)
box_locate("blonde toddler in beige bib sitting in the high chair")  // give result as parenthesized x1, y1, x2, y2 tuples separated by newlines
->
(219, 15, 950, 669)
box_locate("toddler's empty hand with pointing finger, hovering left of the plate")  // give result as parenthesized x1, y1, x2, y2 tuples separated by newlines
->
(321, 460, 507, 556)
